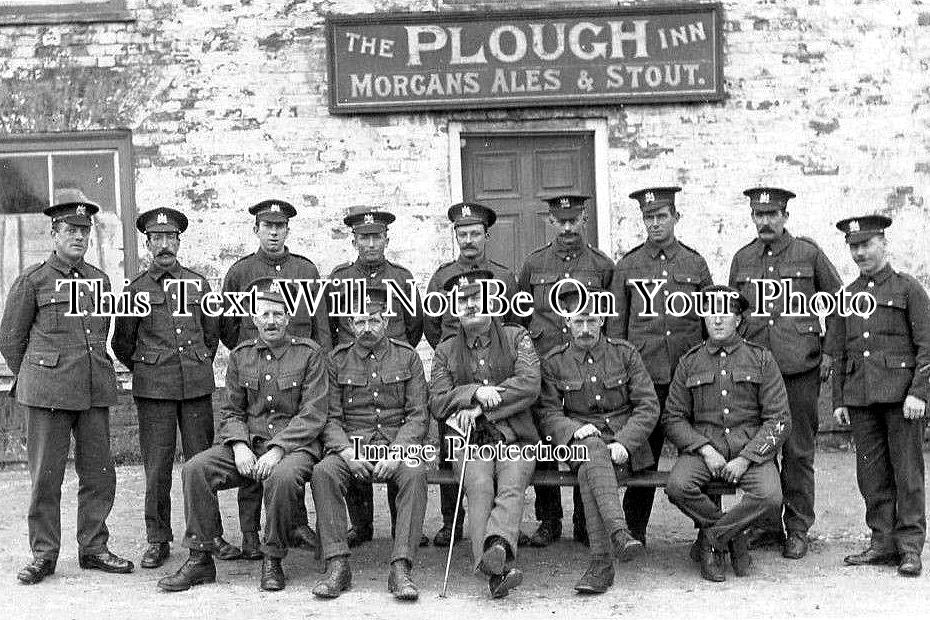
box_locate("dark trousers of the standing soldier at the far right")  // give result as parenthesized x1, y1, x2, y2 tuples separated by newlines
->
(849, 403, 927, 554)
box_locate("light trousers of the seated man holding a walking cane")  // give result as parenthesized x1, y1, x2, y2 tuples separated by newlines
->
(453, 450, 536, 568)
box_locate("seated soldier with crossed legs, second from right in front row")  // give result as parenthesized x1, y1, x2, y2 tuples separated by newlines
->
(536, 287, 659, 594)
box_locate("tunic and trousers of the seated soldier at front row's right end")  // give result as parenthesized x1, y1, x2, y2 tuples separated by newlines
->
(662, 335, 791, 544)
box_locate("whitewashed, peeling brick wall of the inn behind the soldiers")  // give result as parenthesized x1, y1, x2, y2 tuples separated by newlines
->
(0, 0, 930, 460)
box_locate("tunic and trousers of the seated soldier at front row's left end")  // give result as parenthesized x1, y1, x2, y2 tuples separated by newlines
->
(181, 336, 329, 557)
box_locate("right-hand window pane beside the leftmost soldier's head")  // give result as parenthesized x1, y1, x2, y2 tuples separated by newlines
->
(52, 151, 123, 290)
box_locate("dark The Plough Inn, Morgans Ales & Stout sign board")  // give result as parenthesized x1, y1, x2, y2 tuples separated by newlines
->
(326, 3, 723, 114)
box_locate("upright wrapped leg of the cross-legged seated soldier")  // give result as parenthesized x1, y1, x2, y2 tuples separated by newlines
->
(572, 437, 629, 556)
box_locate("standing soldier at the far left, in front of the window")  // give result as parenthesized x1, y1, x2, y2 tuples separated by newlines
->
(0, 202, 133, 584)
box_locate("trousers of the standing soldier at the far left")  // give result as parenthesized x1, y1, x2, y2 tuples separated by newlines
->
(26, 407, 116, 560)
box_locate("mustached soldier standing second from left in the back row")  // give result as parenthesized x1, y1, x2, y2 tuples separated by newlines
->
(113, 208, 225, 568)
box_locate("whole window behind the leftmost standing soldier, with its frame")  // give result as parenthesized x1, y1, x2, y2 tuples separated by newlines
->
(0, 130, 137, 314)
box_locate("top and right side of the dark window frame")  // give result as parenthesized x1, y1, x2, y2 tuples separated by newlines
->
(0, 129, 139, 278)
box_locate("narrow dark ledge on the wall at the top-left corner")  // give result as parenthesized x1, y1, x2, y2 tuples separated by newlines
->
(0, 0, 133, 24)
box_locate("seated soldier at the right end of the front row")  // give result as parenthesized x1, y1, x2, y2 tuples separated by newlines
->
(662, 285, 791, 581)
